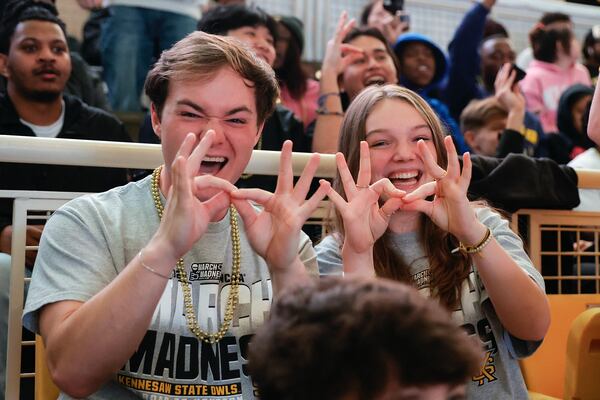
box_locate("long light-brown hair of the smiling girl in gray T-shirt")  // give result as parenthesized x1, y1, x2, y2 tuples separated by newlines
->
(333, 85, 470, 309)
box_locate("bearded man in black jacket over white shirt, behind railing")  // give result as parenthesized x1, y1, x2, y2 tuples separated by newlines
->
(0, 0, 130, 264)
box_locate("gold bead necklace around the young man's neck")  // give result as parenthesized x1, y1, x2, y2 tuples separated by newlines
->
(151, 165, 241, 344)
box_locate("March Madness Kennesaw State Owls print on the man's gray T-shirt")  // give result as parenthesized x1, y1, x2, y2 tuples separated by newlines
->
(117, 272, 273, 400)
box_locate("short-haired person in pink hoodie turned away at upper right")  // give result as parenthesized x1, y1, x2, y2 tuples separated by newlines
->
(521, 13, 592, 133)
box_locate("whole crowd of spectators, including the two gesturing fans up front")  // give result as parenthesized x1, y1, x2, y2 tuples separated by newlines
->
(0, 0, 600, 400)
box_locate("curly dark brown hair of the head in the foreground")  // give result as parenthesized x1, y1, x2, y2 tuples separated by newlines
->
(249, 278, 481, 400)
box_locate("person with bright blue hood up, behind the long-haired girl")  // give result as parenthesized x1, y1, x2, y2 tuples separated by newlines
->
(394, 33, 469, 154)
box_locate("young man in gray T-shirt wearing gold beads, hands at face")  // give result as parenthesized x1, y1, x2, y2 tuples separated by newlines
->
(24, 32, 329, 399)
